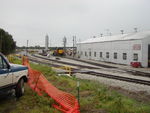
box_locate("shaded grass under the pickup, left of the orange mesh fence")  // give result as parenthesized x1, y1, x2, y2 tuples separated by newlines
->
(0, 85, 59, 113)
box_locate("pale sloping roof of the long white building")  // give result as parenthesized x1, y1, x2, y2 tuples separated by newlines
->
(78, 31, 150, 44)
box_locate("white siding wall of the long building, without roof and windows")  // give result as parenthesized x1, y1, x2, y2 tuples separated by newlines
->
(77, 40, 145, 67)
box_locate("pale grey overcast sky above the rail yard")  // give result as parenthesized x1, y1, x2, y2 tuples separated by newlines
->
(0, 0, 150, 46)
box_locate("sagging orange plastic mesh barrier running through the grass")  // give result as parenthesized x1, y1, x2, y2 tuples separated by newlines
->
(23, 57, 80, 113)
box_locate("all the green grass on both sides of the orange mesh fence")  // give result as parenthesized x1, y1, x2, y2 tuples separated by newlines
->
(0, 59, 150, 113)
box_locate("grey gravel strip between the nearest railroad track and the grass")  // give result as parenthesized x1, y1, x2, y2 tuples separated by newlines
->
(75, 73, 150, 95)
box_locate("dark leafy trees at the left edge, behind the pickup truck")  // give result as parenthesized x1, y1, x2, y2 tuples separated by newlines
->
(0, 28, 16, 55)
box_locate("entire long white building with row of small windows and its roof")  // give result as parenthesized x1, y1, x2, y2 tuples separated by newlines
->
(77, 31, 150, 67)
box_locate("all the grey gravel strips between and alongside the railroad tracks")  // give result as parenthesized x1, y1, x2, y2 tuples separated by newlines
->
(31, 54, 150, 100)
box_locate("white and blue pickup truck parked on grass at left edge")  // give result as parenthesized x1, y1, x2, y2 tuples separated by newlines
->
(0, 53, 28, 98)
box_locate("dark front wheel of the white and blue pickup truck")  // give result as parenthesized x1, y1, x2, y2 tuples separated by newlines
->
(15, 79, 24, 98)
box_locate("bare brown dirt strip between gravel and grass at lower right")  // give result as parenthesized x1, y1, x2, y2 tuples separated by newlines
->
(109, 86, 150, 103)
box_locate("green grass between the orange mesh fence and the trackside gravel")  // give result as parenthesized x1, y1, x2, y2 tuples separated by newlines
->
(31, 64, 150, 113)
